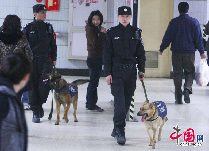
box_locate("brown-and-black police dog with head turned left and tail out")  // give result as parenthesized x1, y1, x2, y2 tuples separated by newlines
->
(44, 72, 89, 125)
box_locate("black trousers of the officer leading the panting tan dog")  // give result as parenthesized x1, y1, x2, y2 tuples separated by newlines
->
(111, 67, 137, 129)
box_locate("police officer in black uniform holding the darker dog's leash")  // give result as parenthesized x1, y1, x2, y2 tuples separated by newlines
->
(24, 4, 57, 123)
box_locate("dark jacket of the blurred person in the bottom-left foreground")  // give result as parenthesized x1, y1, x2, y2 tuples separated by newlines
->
(0, 76, 28, 151)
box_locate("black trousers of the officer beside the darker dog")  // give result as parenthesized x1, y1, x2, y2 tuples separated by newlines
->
(29, 57, 52, 113)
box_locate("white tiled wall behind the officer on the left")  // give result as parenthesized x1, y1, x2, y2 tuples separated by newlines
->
(0, 0, 87, 69)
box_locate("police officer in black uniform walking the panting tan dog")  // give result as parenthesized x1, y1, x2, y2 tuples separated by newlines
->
(104, 6, 146, 145)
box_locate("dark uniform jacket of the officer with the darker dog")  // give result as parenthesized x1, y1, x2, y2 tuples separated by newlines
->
(23, 20, 57, 61)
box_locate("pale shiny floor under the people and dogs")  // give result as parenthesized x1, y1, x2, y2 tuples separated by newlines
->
(26, 77, 209, 151)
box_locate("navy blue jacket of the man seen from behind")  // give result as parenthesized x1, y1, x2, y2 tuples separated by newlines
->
(160, 14, 204, 54)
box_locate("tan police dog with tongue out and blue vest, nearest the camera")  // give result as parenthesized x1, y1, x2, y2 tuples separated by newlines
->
(137, 101, 168, 149)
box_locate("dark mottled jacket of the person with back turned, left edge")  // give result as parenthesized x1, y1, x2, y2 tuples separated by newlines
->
(0, 30, 33, 63)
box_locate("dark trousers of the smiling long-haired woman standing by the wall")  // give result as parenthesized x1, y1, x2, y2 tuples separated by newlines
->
(86, 58, 102, 108)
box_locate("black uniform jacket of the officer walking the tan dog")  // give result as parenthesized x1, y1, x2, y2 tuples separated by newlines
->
(104, 24, 146, 75)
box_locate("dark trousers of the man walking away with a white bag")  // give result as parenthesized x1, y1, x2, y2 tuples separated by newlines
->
(172, 53, 195, 95)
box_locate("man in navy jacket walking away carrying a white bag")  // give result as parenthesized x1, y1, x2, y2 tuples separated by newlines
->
(160, 2, 206, 104)
